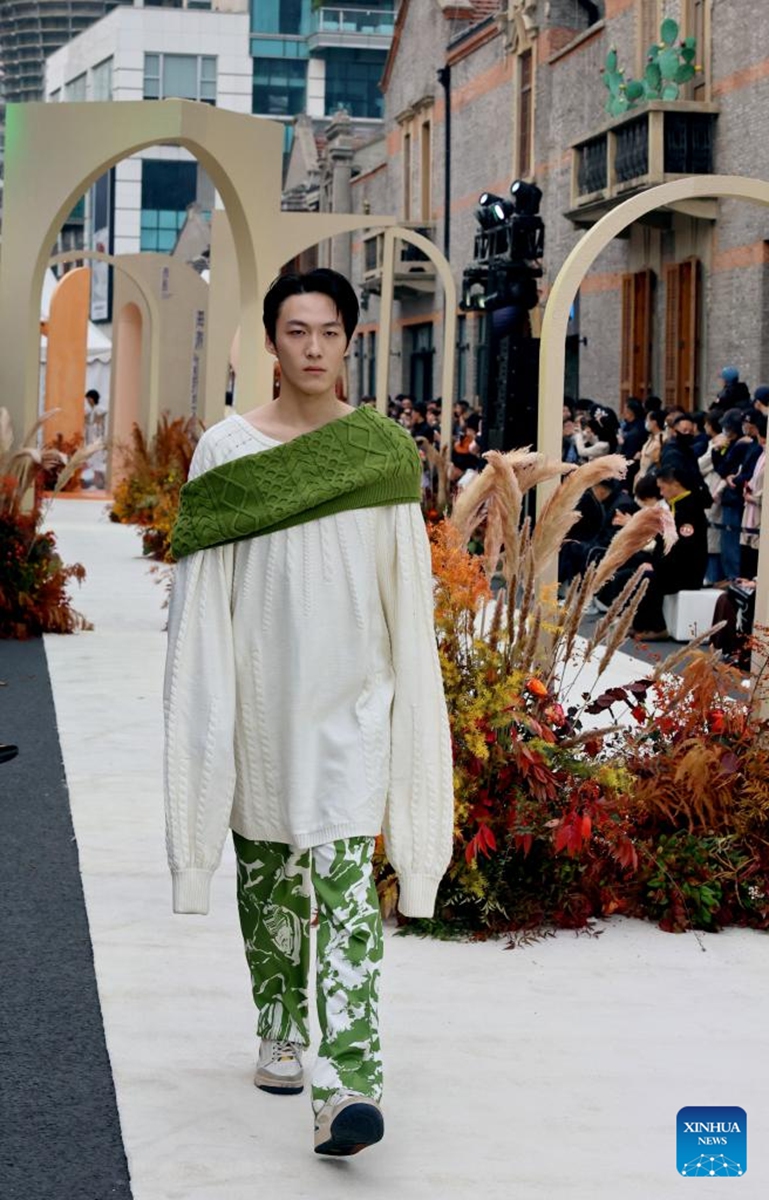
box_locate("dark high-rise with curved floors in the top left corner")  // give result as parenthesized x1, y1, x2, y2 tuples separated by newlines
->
(0, 0, 132, 103)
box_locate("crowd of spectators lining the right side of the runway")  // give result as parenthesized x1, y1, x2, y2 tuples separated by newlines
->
(371, 366, 769, 654)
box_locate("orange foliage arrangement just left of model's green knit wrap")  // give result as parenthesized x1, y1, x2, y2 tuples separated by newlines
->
(109, 413, 203, 563)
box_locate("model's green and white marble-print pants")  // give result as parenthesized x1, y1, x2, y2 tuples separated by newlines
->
(233, 833, 383, 1112)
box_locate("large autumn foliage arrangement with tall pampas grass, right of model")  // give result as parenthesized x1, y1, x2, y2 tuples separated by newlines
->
(376, 451, 769, 941)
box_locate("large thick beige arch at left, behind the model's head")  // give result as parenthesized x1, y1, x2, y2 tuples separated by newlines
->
(0, 100, 395, 441)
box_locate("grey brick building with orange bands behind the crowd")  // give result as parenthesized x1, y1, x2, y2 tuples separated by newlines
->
(309, 0, 769, 420)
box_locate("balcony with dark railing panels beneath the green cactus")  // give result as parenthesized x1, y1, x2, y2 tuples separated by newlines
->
(565, 101, 719, 227)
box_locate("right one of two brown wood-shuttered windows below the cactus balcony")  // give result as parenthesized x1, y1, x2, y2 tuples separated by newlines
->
(665, 258, 701, 413)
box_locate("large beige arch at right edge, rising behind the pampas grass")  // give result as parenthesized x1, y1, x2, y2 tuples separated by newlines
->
(537, 175, 769, 681)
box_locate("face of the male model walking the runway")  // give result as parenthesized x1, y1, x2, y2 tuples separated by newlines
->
(265, 292, 347, 395)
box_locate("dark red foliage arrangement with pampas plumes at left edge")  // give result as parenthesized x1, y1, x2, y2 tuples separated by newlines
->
(0, 408, 101, 638)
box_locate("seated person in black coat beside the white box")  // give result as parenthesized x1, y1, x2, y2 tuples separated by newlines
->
(632, 467, 708, 642)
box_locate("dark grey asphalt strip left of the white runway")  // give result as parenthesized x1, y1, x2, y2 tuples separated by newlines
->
(0, 638, 131, 1200)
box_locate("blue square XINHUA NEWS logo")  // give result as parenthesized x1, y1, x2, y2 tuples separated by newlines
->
(675, 1106, 747, 1180)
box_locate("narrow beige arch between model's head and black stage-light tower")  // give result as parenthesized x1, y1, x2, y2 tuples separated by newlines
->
(377, 226, 457, 446)
